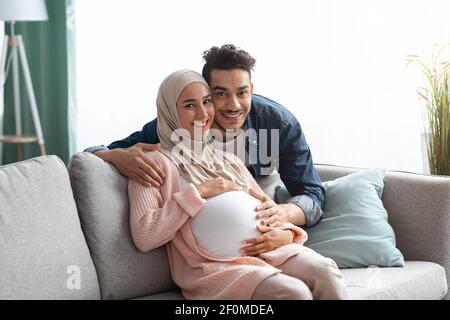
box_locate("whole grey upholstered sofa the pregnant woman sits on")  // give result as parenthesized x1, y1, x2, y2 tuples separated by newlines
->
(0, 153, 450, 299)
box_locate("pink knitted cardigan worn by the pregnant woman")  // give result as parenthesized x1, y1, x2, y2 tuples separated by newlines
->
(128, 151, 307, 300)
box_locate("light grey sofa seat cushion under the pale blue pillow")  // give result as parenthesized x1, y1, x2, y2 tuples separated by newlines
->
(341, 261, 447, 300)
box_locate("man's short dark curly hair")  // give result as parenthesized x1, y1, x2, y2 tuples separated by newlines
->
(202, 44, 256, 84)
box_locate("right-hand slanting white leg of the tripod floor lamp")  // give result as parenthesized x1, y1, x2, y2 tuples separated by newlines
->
(17, 35, 46, 155)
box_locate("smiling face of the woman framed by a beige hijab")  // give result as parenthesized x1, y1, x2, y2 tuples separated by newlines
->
(177, 82, 215, 140)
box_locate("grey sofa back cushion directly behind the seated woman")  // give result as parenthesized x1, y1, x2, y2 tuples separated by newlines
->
(69, 152, 176, 299)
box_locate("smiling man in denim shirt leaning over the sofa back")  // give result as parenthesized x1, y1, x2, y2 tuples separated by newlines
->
(86, 45, 324, 253)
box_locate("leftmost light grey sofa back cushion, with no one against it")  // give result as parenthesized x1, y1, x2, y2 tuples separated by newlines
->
(0, 156, 100, 299)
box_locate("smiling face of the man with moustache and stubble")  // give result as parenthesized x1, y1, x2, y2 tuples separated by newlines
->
(210, 69, 253, 130)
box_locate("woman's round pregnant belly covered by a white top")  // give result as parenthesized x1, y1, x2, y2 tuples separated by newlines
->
(189, 191, 261, 258)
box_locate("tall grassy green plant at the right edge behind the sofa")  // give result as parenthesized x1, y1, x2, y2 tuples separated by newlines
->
(405, 43, 450, 175)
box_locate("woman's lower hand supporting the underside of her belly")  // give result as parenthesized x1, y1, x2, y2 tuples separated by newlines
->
(241, 225, 294, 256)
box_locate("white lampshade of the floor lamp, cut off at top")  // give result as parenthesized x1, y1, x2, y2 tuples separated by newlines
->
(0, 0, 48, 21)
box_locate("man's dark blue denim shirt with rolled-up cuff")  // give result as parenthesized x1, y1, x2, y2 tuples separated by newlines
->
(85, 94, 325, 227)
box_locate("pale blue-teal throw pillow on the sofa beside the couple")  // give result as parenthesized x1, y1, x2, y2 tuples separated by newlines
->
(277, 169, 405, 268)
